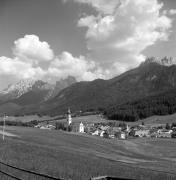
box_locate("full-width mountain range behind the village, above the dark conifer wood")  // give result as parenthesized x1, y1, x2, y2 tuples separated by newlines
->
(0, 57, 176, 117)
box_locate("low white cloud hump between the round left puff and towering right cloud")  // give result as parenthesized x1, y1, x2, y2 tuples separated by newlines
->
(47, 52, 104, 81)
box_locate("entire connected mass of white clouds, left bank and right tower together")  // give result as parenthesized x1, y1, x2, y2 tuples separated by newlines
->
(0, 0, 175, 89)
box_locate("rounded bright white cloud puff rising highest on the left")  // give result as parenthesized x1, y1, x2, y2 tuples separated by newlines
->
(13, 35, 54, 63)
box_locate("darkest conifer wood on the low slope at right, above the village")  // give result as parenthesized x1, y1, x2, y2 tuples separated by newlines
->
(104, 90, 176, 121)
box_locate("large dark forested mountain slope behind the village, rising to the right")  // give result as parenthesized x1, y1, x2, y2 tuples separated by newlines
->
(44, 57, 176, 112)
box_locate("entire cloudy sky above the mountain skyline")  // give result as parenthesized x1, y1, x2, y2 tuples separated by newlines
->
(0, 0, 176, 90)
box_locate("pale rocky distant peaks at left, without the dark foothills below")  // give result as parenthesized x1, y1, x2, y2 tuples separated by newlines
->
(0, 77, 76, 109)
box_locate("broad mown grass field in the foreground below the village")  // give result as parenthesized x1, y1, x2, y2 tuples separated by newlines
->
(0, 127, 176, 180)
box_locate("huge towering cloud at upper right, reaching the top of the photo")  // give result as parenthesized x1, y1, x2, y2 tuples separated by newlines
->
(75, 0, 174, 73)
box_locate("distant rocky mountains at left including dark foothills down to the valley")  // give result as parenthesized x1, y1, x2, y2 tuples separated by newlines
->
(0, 76, 76, 115)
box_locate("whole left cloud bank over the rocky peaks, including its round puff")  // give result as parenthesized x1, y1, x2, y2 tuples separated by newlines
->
(0, 35, 105, 88)
